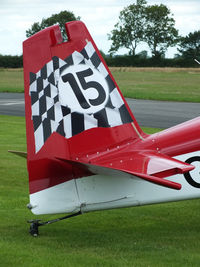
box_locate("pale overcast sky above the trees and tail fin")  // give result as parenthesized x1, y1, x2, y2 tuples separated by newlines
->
(0, 0, 200, 57)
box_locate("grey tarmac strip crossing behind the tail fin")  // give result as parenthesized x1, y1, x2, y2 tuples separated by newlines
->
(0, 93, 200, 128)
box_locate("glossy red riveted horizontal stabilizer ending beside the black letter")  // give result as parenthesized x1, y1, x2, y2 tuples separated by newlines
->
(91, 151, 194, 178)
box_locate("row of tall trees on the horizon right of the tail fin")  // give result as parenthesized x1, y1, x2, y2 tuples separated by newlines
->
(108, 0, 200, 63)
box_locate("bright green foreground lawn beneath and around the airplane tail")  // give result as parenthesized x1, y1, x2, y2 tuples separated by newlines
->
(0, 116, 200, 267)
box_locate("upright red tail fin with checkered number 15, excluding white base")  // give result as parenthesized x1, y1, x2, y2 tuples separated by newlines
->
(23, 21, 144, 196)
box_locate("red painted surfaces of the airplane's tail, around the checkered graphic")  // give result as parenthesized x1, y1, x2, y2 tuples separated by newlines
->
(23, 21, 200, 193)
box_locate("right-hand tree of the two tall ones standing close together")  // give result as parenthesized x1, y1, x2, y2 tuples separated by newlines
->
(145, 4, 178, 58)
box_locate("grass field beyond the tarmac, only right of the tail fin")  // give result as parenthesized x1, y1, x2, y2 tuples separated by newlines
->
(113, 69, 200, 102)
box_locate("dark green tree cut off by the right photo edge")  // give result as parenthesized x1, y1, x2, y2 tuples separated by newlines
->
(178, 30, 200, 59)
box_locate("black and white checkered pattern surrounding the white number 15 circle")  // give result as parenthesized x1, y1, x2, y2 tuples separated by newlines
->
(30, 42, 132, 153)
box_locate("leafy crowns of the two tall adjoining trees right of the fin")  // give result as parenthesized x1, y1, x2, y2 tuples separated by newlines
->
(108, 0, 178, 58)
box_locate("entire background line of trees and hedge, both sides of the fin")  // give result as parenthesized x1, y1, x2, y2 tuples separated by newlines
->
(0, 3, 200, 67)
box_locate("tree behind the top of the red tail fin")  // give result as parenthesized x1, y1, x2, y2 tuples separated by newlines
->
(26, 10, 80, 41)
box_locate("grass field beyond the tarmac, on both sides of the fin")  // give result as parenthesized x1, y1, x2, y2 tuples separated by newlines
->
(0, 68, 200, 102)
